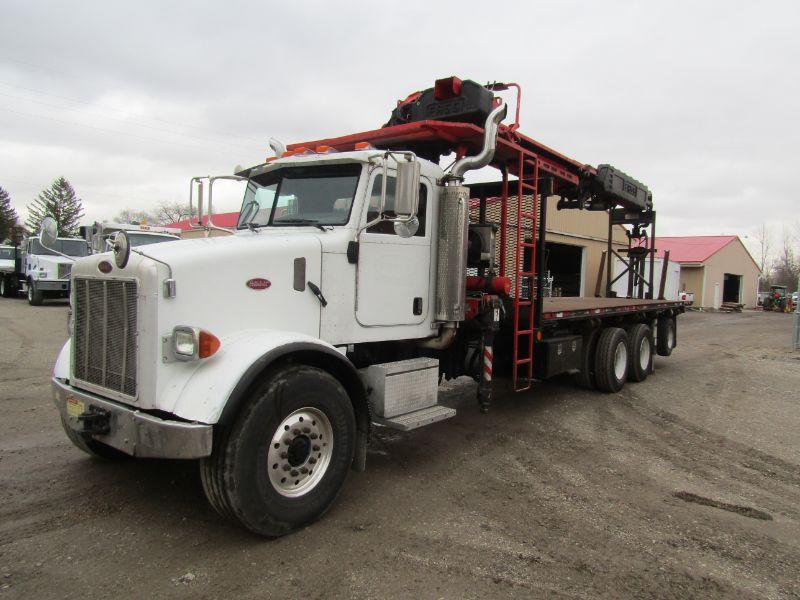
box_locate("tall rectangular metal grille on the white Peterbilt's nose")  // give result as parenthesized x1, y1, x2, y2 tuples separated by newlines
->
(72, 277, 136, 397)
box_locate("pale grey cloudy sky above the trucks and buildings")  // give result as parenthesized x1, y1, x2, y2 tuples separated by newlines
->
(0, 0, 800, 246)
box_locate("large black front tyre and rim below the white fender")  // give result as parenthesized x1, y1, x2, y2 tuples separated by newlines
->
(200, 366, 356, 537)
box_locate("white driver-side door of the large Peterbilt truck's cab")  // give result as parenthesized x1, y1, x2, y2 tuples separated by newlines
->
(355, 172, 432, 327)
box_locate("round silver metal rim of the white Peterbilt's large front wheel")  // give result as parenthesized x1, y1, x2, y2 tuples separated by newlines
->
(267, 407, 333, 498)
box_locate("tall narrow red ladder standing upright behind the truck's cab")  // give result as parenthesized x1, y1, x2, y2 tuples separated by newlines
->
(512, 152, 539, 392)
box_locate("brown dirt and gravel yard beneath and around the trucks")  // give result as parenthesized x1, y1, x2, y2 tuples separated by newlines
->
(0, 299, 800, 598)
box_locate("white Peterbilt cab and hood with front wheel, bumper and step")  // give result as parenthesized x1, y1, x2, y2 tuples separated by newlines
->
(53, 117, 494, 535)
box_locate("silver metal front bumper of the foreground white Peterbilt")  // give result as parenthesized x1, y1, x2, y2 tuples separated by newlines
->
(52, 377, 212, 458)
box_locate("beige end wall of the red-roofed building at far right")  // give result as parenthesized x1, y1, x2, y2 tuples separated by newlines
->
(695, 238, 759, 308)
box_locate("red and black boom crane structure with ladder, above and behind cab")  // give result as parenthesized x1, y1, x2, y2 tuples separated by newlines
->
(287, 77, 656, 391)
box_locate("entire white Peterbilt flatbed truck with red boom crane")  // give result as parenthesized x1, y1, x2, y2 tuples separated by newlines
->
(48, 78, 684, 536)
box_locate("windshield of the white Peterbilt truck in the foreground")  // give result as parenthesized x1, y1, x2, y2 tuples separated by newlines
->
(238, 163, 361, 229)
